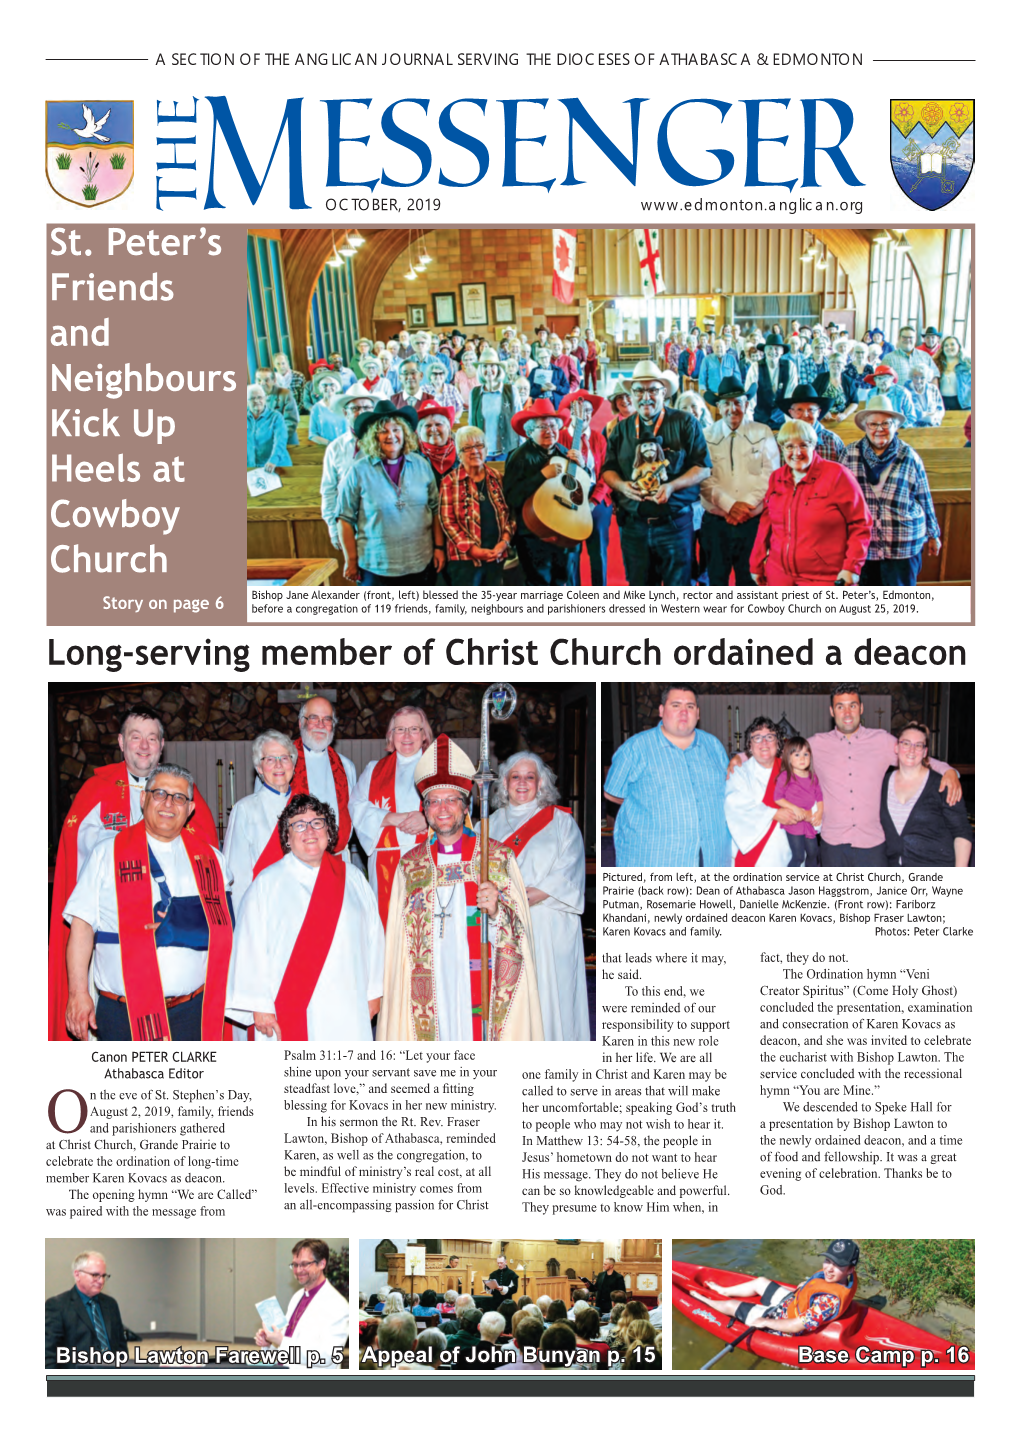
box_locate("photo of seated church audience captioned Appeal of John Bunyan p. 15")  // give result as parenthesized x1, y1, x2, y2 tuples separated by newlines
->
(358, 1238, 662, 1375)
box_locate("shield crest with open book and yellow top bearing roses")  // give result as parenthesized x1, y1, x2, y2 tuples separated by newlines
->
(889, 100, 974, 212)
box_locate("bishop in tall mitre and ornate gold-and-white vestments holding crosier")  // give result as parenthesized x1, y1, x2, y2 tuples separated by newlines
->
(376, 735, 544, 1043)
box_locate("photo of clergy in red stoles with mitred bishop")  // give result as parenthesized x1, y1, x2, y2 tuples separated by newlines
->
(48, 682, 596, 1044)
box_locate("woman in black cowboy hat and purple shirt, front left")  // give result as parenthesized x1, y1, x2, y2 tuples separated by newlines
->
(338, 399, 445, 586)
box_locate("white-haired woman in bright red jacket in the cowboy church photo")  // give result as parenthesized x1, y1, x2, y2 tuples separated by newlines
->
(750, 419, 872, 589)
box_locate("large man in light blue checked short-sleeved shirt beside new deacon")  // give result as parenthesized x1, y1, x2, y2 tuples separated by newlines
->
(605, 684, 730, 866)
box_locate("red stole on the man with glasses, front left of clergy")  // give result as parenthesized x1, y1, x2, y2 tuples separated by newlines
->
(113, 821, 234, 1043)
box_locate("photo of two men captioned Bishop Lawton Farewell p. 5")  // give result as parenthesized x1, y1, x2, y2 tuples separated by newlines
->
(44, 1235, 351, 1375)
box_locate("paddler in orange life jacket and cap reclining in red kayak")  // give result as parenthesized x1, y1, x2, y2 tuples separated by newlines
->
(689, 1238, 860, 1334)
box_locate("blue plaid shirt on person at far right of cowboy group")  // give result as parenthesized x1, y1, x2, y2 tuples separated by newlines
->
(843, 438, 942, 560)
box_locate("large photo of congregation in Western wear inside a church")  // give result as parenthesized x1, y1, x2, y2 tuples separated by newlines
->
(245, 226, 972, 589)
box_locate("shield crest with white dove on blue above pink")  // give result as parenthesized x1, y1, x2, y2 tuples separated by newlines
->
(46, 100, 135, 207)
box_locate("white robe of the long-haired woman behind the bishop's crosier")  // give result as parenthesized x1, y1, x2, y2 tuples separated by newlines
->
(489, 800, 591, 1043)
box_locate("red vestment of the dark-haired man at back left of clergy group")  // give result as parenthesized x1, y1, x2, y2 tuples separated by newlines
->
(49, 760, 219, 1043)
